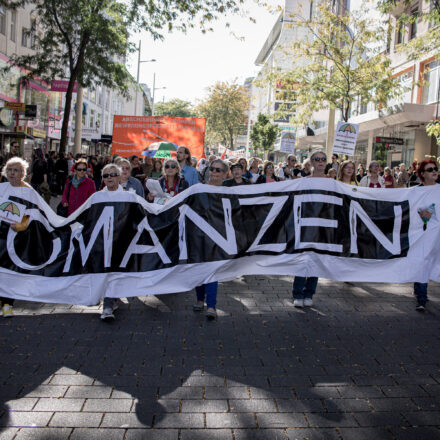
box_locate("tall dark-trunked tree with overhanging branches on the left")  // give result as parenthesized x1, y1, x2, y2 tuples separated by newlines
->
(0, 0, 251, 150)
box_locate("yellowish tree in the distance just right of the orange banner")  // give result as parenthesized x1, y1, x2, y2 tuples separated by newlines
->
(196, 82, 249, 150)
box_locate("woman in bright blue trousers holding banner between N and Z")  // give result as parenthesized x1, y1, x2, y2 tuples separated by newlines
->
(193, 159, 228, 320)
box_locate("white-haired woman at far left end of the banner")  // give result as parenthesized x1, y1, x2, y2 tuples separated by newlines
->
(0, 157, 31, 318)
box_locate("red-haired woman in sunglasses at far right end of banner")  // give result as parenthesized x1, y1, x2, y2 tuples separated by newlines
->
(414, 159, 438, 312)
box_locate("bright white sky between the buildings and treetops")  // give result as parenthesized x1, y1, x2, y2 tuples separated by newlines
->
(128, 0, 279, 104)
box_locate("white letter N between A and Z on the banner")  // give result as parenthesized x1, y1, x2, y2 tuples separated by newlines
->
(179, 198, 237, 260)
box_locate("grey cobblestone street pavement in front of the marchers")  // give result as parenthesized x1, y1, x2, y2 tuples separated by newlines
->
(0, 276, 440, 440)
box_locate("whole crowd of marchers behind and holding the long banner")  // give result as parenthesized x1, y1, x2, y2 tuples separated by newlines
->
(0, 146, 439, 321)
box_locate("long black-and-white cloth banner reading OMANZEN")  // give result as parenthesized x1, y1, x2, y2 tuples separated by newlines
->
(0, 178, 440, 304)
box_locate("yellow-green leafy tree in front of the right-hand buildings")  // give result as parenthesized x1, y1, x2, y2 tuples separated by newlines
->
(268, 0, 399, 125)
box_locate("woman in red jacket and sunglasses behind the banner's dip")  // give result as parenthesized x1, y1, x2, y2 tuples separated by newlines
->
(61, 159, 96, 215)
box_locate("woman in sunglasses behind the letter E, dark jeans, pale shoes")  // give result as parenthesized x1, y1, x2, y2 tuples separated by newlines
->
(292, 151, 327, 308)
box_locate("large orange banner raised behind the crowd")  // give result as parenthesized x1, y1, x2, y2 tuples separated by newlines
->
(112, 115, 206, 159)
